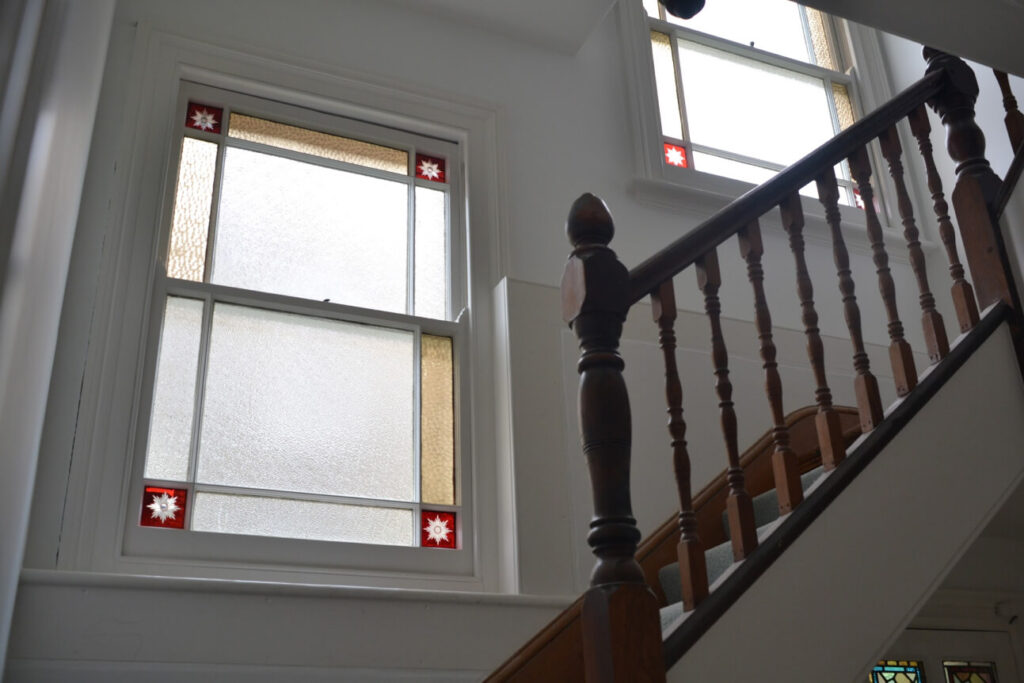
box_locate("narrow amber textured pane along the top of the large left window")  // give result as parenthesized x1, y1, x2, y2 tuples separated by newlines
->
(227, 114, 409, 175)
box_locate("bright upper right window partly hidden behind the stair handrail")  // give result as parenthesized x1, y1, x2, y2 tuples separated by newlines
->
(643, 0, 856, 206)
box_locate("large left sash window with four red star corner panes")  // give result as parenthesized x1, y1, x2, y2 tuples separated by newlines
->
(129, 84, 465, 561)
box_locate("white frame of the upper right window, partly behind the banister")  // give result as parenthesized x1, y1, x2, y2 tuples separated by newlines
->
(617, 0, 905, 233)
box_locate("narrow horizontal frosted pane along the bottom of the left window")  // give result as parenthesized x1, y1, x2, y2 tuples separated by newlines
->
(191, 492, 413, 546)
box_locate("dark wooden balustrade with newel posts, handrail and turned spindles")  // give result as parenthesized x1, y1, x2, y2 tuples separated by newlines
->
(562, 48, 1024, 681)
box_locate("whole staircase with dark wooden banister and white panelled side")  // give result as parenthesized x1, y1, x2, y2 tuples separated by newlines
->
(488, 48, 1024, 681)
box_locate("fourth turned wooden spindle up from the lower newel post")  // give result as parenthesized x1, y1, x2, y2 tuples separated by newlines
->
(779, 193, 846, 471)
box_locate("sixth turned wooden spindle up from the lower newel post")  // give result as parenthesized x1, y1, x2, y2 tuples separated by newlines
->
(849, 147, 918, 396)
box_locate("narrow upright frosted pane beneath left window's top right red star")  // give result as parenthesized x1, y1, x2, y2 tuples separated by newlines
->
(415, 187, 449, 319)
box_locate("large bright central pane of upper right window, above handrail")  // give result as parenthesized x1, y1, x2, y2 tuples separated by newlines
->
(679, 41, 835, 166)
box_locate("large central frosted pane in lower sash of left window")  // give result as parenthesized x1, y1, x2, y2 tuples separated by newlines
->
(197, 304, 416, 501)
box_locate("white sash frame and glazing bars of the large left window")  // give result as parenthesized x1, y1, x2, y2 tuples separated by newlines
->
(124, 81, 473, 565)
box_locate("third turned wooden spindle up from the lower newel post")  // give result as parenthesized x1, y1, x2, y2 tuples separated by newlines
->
(738, 220, 804, 514)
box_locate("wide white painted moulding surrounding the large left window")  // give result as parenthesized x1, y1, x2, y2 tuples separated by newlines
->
(51, 24, 507, 590)
